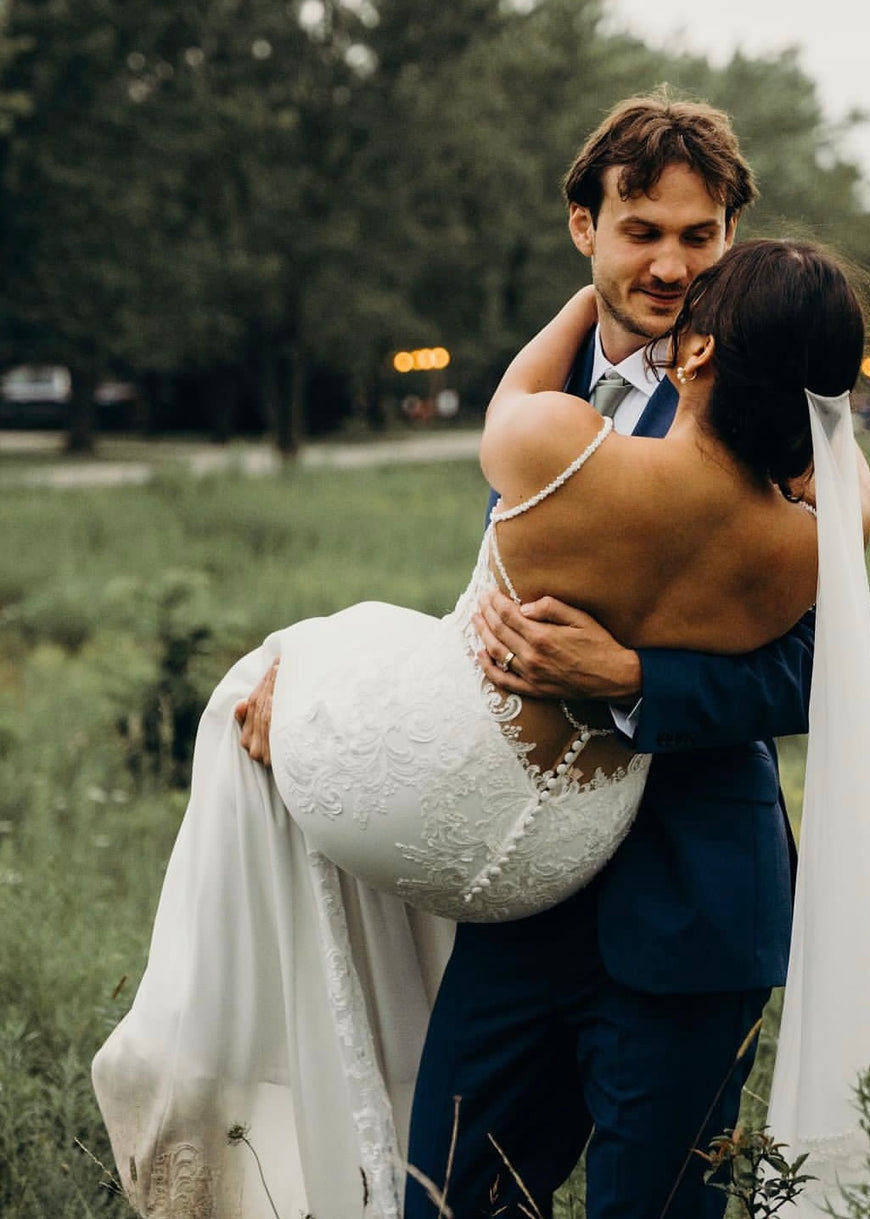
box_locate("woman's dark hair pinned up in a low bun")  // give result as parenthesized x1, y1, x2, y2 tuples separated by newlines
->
(670, 240, 864, 485)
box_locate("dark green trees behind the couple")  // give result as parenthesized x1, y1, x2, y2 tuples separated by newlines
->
(0, 0, 870, 450)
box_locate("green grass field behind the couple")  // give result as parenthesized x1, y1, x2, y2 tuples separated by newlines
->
(0, 462, 803, 1219)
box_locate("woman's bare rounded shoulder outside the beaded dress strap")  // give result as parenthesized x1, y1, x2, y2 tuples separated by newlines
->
(480, 390, 603, 496)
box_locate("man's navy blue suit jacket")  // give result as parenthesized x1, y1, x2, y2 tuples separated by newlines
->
(492, 344, 814, 993)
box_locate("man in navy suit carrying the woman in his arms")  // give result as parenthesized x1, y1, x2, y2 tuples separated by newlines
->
(406, 94, 813, 1219)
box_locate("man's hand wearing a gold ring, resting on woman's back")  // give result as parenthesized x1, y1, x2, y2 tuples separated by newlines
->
(472, 592, 641, 703)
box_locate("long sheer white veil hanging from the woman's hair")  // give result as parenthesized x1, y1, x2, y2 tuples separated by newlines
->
(768, 390, 870, 1219)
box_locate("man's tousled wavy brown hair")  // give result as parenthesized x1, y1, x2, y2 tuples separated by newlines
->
(563, 85, 758, 222)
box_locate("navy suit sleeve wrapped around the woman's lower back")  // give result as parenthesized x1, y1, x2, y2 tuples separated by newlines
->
(634, 610, 815, 753)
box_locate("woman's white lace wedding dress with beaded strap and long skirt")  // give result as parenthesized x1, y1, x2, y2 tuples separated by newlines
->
(94, 421, 649, 1219)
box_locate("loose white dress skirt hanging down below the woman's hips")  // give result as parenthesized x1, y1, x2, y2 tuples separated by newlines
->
(93, 635, 453, 1219)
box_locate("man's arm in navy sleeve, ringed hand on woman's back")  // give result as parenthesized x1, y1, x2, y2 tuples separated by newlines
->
(475, 592, 815, 752)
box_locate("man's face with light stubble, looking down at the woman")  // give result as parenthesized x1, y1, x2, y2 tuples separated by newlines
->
(569, 165, 736, 363)
